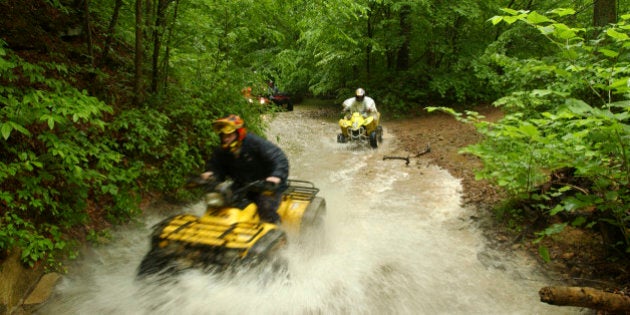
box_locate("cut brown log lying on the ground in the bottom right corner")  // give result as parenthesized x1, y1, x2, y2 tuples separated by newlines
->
(538, 287, 630, 312)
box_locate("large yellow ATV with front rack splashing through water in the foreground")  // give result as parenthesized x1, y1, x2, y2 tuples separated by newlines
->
(138, 179, 326, 278)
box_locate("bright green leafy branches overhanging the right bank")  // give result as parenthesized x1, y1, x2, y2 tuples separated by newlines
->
(462, 9, 630, 254)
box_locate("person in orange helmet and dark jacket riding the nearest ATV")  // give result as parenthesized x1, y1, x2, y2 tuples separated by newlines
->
(201, 115, 289, 223)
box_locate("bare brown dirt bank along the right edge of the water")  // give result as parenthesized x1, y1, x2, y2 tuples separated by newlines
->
(386, 106, 628, 292)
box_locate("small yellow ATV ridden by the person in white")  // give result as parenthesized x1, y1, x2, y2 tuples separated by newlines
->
(337, 112, 383, 148)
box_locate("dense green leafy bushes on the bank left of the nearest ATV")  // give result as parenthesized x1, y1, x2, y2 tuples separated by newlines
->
(0, 42, 143, 266)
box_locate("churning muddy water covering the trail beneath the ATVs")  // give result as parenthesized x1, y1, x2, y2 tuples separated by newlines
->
(38, 107, 588, 314)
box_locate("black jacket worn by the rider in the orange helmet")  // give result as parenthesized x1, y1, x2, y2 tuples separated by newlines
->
(206, 133, 289, 191)
